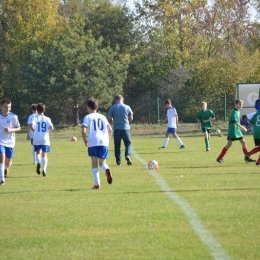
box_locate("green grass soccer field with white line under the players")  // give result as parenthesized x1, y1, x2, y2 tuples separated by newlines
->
(0, 127, 260, 260)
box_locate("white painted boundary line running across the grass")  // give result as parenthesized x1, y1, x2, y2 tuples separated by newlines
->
(132, 148, 230, 260)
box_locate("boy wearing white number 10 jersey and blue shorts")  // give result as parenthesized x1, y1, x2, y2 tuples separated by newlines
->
(81, 99, 113, 189)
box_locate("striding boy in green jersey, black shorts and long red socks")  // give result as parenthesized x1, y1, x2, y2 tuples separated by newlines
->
(217, 99, 254, 163)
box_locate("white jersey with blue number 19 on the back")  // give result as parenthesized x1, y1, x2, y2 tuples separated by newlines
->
(32, 115, 53, 145)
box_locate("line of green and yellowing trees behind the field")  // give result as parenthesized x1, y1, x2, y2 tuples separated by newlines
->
(0, 0, 260, 125)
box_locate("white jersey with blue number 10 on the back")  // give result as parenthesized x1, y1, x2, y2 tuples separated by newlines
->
(82, 113, 109, 147)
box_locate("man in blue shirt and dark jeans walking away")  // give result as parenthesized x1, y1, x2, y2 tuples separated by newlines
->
(107, 95, 133, 165)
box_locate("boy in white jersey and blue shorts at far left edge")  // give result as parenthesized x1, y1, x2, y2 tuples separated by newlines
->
(0, 98, 21, 185)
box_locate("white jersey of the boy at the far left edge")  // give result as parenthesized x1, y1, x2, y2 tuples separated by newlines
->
(0, 112, 20, 148)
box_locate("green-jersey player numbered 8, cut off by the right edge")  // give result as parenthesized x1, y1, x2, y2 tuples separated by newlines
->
(245, 111, 260, 165)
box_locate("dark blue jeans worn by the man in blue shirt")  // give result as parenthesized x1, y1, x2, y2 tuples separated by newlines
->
(114, 130, 131, 164)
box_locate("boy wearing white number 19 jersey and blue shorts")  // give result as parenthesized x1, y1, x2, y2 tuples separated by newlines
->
(31, 103, 54, 177)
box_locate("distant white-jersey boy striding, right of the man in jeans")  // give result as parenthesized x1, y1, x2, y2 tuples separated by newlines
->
(158, 99, 185, 149)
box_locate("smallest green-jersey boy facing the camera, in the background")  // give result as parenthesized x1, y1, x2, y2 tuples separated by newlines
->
(197, 102, 215, 151)
